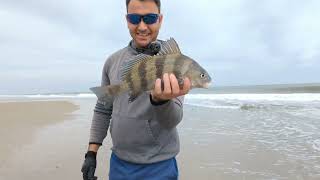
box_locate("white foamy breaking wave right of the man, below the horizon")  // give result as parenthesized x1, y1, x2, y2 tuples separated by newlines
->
(185, 93, 320, 110)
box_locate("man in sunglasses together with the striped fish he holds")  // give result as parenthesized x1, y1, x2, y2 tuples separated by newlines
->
(81, 0, 211, 180)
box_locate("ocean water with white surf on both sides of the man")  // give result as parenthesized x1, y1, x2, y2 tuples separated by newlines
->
(0, 84, 320, 179)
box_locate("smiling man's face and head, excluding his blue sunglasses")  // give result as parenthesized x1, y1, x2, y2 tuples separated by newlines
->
(127, 0, 162, 47)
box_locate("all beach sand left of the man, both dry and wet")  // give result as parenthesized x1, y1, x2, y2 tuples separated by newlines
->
(0, 99, 111, 180)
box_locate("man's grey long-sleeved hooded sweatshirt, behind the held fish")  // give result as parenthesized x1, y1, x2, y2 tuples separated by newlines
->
(90, 41, 183, 164)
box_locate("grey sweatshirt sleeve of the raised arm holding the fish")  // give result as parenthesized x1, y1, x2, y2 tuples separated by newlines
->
(150, 95, 184, 129)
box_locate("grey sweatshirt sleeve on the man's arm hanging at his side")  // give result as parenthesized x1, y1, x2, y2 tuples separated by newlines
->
(89, 59, 113, 145)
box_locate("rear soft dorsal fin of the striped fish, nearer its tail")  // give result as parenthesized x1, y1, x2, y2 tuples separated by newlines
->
(120, 54, 152, 80)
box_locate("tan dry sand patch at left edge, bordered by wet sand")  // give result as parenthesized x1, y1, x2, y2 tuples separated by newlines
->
(0, 101, 78, 158)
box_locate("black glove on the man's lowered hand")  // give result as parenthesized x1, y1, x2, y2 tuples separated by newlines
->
(81, 151, 97, 180)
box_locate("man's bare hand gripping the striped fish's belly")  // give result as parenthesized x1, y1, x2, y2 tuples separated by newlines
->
(151, 73, 191, 102)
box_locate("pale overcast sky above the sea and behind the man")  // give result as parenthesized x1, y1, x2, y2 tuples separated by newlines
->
(0, 0, 320, 94)
